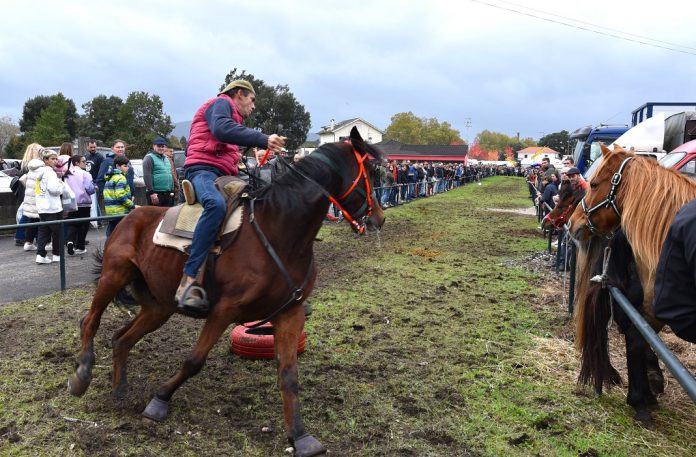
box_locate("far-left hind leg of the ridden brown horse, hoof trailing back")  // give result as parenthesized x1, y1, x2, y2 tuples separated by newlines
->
(68, 258, 132, 396)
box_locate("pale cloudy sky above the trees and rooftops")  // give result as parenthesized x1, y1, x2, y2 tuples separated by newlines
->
(0, 0, 696, 140)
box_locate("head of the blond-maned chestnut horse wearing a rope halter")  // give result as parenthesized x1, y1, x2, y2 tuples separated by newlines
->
(569, 144, 635, 243)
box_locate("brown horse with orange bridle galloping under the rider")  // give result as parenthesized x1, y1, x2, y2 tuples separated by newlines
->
(69, 128, 384, 456)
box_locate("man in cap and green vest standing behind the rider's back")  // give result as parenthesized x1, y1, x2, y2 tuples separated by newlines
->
(143, 136, 174, 207)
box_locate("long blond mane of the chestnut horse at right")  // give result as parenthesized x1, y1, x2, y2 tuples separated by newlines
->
(616, 151, 696, 284)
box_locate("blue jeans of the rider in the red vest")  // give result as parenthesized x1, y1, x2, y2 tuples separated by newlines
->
(184, 170, 227, 278)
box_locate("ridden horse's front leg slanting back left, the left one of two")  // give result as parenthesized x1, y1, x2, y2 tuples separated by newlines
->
(143, 302, 232, 422)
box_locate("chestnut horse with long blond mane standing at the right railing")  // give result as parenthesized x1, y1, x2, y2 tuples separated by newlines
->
(569, 145, 696, 427)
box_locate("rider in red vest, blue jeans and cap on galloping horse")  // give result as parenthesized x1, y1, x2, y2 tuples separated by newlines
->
(174, 79, 285, 314)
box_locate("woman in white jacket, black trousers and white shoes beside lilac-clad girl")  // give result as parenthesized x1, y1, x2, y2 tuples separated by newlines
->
(35, 149, 63, 264)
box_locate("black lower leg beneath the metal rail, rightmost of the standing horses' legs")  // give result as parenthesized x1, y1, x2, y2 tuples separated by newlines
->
(625, 326, 657, 429)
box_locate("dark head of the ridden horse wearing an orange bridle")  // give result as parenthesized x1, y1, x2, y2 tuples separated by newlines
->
(313, 127, 385, 234)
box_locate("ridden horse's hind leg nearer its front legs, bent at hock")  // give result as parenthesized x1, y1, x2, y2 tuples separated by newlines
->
(111, 303, 172, 398)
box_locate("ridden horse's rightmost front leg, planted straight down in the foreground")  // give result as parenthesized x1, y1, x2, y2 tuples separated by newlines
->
(273, 304, 326, 457)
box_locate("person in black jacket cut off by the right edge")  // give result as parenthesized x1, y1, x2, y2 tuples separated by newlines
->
(653, 200, 696, 343)
